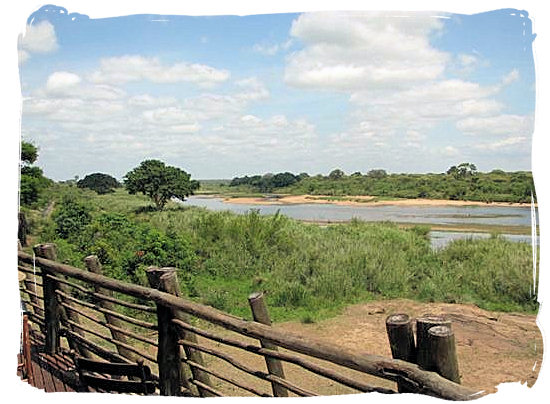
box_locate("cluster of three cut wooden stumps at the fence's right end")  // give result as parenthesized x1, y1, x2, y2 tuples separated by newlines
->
(386, 313, 460, 393)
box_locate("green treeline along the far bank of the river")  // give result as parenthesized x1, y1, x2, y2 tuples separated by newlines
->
(230, 163, 535, 202)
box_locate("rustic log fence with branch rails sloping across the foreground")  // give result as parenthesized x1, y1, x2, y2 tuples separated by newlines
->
(18, 244, 479, 400)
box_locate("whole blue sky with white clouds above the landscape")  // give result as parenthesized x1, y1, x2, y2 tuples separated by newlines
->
(18, 6, 535, 180)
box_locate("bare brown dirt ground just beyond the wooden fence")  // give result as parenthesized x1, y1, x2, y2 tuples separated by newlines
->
(197, 300, 542, 395)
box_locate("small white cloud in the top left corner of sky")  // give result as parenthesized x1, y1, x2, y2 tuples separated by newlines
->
(18, 21, 59, 63)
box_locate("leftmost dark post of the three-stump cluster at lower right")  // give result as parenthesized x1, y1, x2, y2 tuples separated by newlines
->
(386, 313, 416, 393)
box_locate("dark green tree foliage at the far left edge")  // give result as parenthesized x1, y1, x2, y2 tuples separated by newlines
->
(19, 142, 52, 207)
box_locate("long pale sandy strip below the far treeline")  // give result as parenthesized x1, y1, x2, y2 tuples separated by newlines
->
(222, 194, 537, 208)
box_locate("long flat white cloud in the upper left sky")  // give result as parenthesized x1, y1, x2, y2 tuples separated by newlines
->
(90, 55, 230, 87)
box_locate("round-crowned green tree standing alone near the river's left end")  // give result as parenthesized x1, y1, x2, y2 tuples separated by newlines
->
(124, 160, 200, 210)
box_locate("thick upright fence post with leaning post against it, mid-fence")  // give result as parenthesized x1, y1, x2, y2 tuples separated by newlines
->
(147, 267, 213, 397)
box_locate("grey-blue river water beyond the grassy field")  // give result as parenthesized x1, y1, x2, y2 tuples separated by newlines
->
(183, 196, 538, 248)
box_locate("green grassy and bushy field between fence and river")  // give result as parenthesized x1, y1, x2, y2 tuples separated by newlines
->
(25, 185, 537, 322)
